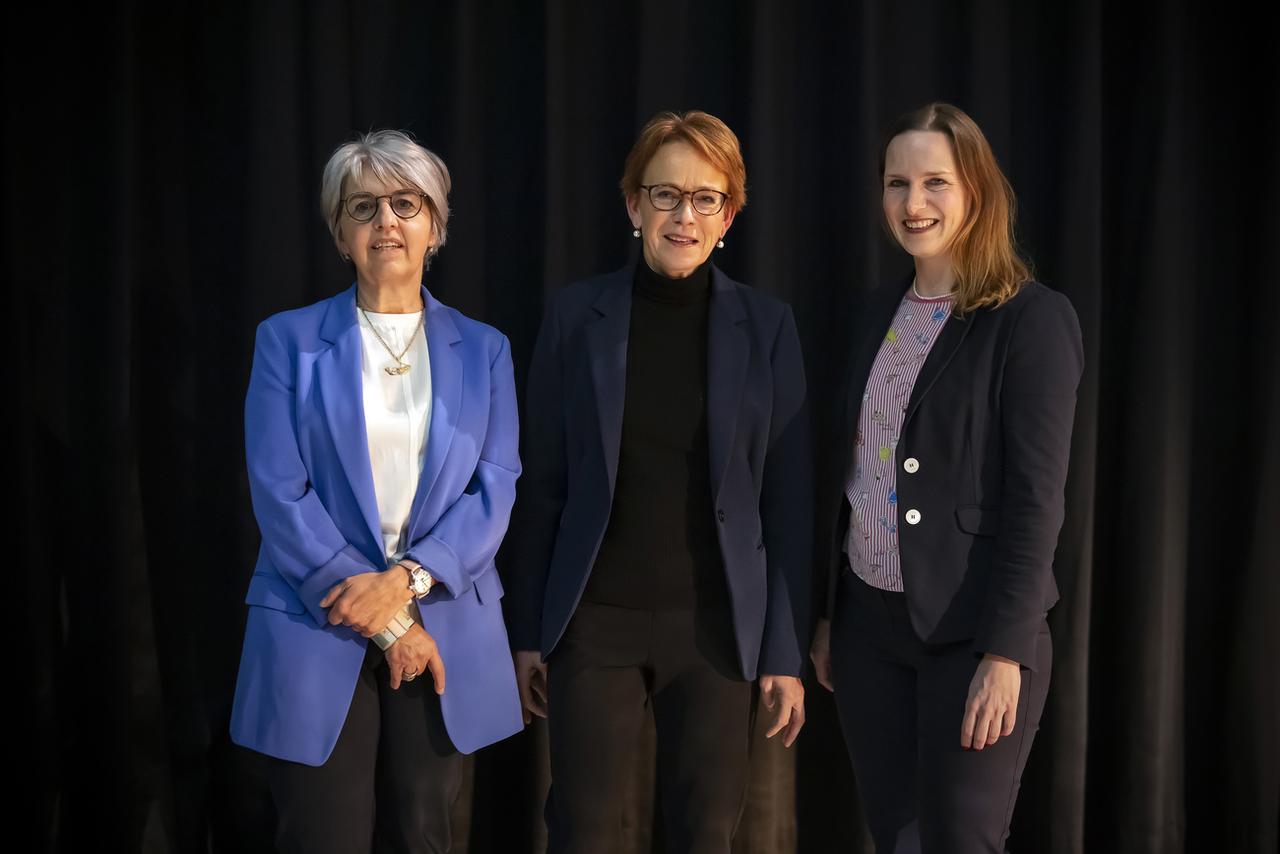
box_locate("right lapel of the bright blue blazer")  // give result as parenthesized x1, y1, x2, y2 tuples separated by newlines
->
(408, 288, 466, 539)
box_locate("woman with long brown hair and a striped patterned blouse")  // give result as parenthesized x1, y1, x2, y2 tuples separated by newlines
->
(810, 104, 1083, 854)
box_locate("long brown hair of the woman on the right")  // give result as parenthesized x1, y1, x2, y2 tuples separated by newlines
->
(879, 101, 1032, 314)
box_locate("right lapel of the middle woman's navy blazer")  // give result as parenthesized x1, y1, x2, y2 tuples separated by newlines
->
(707, 266, 751, 498)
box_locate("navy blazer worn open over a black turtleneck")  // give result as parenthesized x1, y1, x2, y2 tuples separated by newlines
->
(507, 265, 813, 679)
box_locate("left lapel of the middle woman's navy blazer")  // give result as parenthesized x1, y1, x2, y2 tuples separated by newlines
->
(585, 266, 634, 495)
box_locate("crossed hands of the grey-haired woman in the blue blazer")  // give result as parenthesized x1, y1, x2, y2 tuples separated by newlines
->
(320, 565, 444, 694)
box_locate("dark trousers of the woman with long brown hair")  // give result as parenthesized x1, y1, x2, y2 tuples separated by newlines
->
(831, 570, 1052, 854)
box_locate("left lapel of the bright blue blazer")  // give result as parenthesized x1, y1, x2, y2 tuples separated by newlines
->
(315, 287, 383, 554)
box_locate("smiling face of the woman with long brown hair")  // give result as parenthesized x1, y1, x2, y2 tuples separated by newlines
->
(883, 131, 968, 261)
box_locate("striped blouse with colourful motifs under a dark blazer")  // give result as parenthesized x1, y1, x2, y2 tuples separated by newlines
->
(845, 291, 952, 590)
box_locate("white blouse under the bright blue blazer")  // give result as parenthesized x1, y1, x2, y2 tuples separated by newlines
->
(356, 303, 431, 566)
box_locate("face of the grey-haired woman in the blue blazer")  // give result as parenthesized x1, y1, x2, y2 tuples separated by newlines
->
(337, 175, 433, 284)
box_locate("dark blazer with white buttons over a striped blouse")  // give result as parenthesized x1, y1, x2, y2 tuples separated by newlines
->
(819, 275, 1084, 665)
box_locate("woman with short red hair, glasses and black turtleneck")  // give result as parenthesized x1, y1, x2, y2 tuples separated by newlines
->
(511, 111, 813, 854)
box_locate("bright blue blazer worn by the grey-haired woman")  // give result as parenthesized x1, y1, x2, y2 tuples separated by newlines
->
(230, 287, 524, 766)
